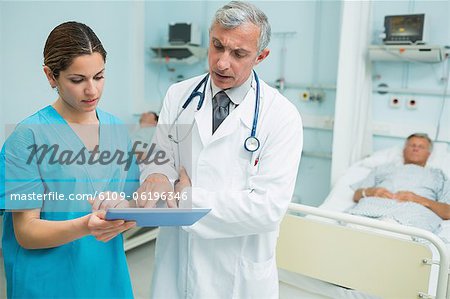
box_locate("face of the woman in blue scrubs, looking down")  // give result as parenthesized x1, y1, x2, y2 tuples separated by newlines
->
(49, 52, 105, 113)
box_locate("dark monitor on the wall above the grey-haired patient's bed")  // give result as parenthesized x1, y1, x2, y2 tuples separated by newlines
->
(384, 14, 425, 43)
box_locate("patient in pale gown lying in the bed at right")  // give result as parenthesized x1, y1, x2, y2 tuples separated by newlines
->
(347, 134, 450, 232)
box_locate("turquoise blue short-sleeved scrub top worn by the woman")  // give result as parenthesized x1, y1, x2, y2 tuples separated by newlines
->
(0, 106, 139, 298)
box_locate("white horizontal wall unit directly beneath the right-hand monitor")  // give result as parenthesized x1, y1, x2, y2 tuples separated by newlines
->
(369, 45, 443, 63)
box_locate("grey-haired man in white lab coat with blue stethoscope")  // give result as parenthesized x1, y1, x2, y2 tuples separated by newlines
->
(138, 1, 303, 298)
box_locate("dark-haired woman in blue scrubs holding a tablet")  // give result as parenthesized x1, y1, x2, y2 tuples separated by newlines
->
(0, 22, 139, 298)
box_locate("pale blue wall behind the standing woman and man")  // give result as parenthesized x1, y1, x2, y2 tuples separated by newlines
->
(0, 1, 340, 205)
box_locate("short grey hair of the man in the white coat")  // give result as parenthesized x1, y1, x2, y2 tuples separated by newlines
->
(210, 1, 271, 53)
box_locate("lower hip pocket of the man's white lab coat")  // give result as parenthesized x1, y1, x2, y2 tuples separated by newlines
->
(235, 256, 278, 298)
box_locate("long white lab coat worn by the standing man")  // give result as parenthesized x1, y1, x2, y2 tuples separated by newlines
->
(141, 76, 303, 299)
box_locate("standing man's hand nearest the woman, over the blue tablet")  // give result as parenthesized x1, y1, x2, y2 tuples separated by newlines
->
(136, 173, 173, 208)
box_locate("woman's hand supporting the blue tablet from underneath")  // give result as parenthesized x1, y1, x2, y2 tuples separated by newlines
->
(87, 211, 136, 242)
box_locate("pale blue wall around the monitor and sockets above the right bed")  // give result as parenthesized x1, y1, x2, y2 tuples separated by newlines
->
(372, 1, 450, 149)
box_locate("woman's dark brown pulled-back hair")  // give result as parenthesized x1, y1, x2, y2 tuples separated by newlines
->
(44, 21, 106, 78)
